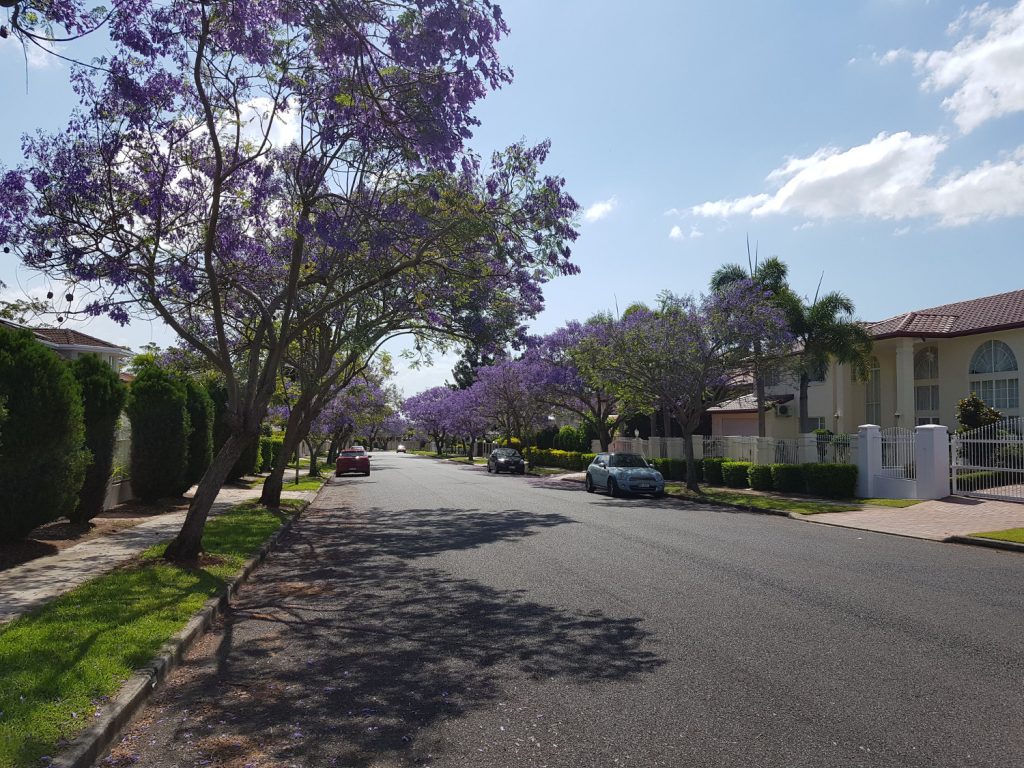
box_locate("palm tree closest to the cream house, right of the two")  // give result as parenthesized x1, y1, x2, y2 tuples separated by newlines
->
(785, 291, 871, 434)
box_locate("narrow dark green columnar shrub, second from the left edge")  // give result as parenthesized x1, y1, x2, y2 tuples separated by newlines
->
(68, 354, 128, 522)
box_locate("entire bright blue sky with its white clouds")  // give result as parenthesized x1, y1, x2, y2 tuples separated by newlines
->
(0, 0, 1024, 394)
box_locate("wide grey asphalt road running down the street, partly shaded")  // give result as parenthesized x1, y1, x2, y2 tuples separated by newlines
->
(109, 454, 1024, 768)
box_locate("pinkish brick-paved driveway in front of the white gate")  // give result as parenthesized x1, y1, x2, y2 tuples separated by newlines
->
(804, 496, 1024, 542)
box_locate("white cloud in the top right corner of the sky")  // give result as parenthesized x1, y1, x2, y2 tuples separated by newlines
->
(882, 0, 1024, 133)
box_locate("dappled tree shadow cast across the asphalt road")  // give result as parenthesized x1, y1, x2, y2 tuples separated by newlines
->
(106, 501, 664, 768)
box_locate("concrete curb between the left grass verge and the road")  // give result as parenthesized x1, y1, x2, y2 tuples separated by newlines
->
(49, 495, 317, 768)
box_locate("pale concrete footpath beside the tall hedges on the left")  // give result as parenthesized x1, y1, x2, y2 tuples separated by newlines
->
(0, 487, 316, 624)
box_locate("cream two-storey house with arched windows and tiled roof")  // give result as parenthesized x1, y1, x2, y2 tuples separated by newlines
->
(711, 291, 1024, 437)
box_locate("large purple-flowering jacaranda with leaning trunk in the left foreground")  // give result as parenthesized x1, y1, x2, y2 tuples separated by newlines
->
(0, 0, 575, 560)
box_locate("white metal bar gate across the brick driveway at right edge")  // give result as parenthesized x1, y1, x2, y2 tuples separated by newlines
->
(949, 418, 1024, 502)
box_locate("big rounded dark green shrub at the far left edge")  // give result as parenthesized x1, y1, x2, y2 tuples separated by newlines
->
(0, 325, 90, 542)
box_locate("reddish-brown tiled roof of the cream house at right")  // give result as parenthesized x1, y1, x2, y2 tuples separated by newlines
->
(867, 291, 1024, 339)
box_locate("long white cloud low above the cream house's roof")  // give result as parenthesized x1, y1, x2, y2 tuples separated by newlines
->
(690, 132, 1024, 226)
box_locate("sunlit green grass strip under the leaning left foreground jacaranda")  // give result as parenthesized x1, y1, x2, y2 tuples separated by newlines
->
(0, 501, 300, 768)
